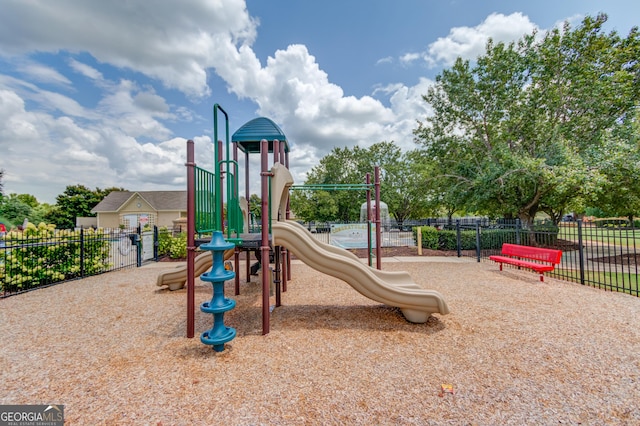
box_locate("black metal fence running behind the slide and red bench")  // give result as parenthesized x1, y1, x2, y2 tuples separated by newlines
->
(303, 217, 640, 296)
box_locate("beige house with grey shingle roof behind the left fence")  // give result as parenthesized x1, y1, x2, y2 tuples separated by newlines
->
(91, 191, 187, 228)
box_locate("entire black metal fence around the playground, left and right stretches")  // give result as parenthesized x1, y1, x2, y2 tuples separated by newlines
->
(0, 218, 640, 298)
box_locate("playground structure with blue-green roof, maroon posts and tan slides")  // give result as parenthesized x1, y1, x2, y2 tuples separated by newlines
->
(171, 104, 449, 351)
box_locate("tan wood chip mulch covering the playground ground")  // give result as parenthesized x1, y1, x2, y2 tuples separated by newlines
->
(0, 257, 640, 425)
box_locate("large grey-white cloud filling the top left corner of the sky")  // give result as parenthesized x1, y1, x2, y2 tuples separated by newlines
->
(0, 0, 256, 97)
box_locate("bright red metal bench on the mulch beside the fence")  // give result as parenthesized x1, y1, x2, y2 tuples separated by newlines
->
(489, 243, 562, 281)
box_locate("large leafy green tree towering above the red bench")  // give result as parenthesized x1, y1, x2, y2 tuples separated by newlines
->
(414, 15, 640, 225)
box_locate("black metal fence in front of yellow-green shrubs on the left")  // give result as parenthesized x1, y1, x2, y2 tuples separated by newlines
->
(0, 226, 141, 298)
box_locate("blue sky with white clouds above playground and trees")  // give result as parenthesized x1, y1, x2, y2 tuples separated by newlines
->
(0, 0, 640, 204)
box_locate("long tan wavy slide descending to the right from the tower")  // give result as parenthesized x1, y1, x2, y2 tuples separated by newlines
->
(271, 221, 449, 323)
